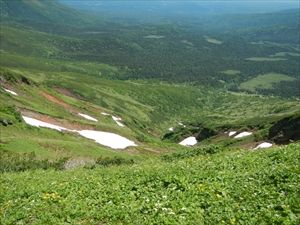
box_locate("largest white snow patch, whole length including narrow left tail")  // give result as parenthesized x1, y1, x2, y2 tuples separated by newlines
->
(22, 116, 137, 149)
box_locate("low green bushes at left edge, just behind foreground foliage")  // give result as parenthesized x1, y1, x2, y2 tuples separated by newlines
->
(0, 150, 69, 173)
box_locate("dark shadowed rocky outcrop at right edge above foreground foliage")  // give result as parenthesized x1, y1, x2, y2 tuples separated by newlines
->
(269, 115, 300, 144)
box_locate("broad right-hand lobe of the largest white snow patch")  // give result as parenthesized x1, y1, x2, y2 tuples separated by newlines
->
(77, 130, 137, 149)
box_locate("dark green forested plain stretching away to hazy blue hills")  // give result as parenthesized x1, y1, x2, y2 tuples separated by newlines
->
(1, 0, 300, 97)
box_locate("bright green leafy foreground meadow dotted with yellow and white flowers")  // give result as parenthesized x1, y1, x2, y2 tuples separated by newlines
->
(0, 144, 300, 224)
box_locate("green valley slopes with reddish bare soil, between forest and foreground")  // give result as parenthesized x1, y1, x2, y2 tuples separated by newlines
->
(0, 68, 299, 159)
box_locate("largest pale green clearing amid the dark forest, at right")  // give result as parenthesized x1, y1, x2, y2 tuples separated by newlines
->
(239, 73, 296, 92)
